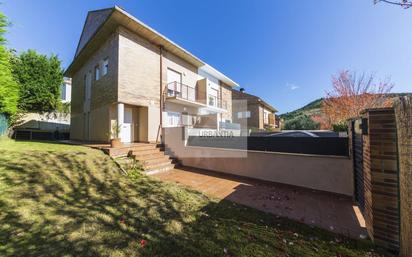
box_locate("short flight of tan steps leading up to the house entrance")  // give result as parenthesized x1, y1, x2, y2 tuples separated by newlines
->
(128, 144, 177, 174)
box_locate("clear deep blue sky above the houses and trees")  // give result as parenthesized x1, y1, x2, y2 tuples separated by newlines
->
(0, 0, 412, 113)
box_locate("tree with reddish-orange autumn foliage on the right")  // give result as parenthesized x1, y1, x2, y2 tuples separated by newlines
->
(318, 71, 393, 129)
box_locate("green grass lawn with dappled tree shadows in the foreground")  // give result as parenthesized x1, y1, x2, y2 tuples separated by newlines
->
(0, 139, 390, 257)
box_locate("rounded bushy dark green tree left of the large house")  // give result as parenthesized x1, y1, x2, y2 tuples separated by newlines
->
(13, 50, 63, 113)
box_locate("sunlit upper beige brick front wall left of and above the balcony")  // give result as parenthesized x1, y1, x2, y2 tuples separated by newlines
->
(118, 27, 197, 107)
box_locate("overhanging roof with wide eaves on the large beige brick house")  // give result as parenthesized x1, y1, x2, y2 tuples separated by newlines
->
(65, 6, 238, 87)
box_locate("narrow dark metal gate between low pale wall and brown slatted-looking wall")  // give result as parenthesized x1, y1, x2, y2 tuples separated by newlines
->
(352, 119, 365, 213)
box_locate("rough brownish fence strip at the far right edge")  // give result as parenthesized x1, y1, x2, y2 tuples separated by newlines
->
(394, 96, 412, 257)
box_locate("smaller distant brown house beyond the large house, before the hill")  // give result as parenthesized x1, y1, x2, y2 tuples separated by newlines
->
(232, 89, 280, 130)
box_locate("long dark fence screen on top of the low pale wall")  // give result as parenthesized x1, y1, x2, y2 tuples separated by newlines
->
(188, 136, 349, 156)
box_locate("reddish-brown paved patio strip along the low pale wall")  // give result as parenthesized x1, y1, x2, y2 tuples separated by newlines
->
(152, 167, 367, 238)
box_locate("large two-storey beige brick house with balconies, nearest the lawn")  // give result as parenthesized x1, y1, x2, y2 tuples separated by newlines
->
(65, 6, 238, 143)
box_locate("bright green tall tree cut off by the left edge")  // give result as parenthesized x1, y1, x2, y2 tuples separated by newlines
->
(0, 12, 19, 116)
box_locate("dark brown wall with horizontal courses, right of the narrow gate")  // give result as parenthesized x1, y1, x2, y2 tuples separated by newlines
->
(363, 109, 400, 252)
